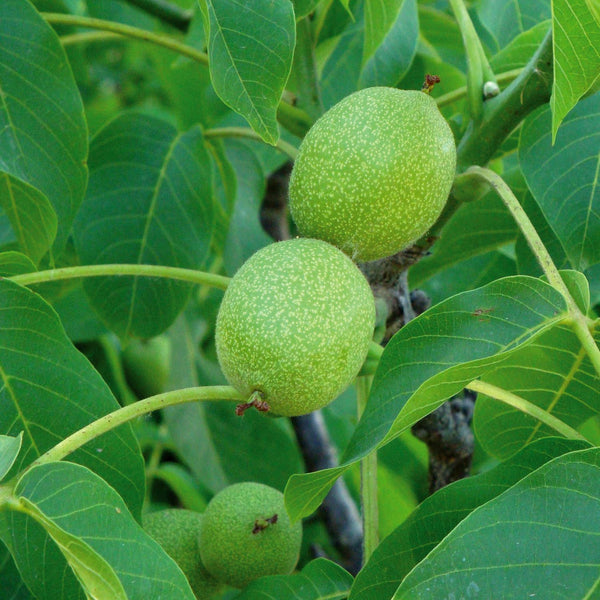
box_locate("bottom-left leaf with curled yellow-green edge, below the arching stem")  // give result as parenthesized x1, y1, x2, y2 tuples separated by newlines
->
(6, 462, 194, 600)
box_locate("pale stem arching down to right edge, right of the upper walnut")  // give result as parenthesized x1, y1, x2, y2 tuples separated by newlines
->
(465, 167, 600, 375)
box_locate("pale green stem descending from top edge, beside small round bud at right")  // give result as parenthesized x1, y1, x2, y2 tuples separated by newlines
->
(450, 0, 485, 123)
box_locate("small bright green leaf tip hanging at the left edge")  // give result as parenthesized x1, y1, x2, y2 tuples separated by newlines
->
(0, 171, 58, 264)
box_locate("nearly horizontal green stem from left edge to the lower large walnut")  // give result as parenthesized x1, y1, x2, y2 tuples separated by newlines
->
(8, 264, 230, 290)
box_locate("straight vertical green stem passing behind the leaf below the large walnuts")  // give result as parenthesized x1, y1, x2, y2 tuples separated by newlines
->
(356, 376, 379, 564)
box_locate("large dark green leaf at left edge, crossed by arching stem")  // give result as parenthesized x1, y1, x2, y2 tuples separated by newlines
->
(0, 279, 144, 515)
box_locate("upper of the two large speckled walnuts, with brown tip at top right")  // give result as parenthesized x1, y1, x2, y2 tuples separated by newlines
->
(289, 87, 456, 261)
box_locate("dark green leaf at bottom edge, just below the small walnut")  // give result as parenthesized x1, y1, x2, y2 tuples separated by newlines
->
(236, 558, 352, 600)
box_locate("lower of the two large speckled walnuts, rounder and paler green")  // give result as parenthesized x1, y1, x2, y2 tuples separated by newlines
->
(215, 239, 375, 416)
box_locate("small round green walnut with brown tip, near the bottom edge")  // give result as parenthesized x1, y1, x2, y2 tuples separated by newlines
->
(200, 482, 302, 588)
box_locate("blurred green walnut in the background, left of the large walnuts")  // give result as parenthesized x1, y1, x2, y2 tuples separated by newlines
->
(122, 335, 171, 398)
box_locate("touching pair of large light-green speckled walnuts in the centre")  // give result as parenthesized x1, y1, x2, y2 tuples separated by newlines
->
(216, 87, 456, 416)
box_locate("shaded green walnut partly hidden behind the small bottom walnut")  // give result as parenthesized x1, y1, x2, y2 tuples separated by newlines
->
(144, 508, 223, 600)
